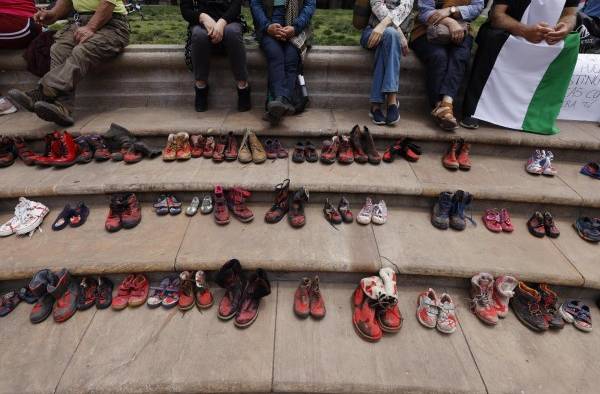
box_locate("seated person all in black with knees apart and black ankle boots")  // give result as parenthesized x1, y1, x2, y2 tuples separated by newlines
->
(180, 0, 252, 112)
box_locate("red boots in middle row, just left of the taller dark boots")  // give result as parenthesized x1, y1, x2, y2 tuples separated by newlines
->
(214, 185, 254, 225)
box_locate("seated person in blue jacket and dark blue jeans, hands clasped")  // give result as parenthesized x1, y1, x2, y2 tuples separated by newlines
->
(250, 0, 317, 124)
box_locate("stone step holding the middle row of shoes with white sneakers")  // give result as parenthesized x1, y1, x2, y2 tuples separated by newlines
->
(0, 201, 600, 289)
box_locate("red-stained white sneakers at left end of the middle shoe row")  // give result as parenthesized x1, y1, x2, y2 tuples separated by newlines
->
(0, 197, 50, 237)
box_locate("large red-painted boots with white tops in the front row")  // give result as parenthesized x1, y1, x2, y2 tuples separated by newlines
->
(352, 268, 403, 342)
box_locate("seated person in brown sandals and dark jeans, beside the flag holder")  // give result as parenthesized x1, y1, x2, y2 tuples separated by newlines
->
(409, 0, 483, 131)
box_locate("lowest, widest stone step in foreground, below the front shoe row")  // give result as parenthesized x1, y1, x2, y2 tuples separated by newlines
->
(0, 281, 600, 394)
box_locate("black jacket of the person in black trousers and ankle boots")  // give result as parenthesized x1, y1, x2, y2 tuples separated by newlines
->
(179, 0, 242, 26)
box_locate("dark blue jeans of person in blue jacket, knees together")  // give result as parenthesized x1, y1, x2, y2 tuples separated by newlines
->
(260, 34, 300, 100)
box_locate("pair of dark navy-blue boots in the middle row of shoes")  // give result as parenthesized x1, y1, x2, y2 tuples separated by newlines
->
(431, 190, 475, 231)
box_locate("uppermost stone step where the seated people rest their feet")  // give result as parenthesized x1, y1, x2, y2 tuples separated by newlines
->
(0, 106, 600, 151)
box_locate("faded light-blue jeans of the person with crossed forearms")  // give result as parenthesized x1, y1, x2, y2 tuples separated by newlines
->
(360, 26, 402, 104)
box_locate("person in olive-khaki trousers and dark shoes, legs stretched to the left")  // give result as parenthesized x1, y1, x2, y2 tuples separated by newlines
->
(8, 0, 129, 127)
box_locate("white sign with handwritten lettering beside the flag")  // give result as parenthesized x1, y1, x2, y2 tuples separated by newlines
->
(558, 54, 600, 122)
